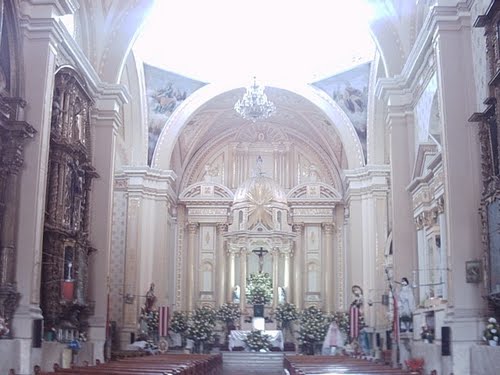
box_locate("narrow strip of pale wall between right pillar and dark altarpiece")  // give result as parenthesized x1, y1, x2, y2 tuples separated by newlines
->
(471, 0, 491, 112)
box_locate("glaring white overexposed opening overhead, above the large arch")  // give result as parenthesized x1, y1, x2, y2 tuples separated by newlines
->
(134, 0, 375, 84)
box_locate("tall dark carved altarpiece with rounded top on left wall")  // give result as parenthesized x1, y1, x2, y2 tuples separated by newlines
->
(41, 68, 97, 340)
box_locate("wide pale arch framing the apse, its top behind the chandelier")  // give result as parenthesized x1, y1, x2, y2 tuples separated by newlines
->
(152, 84, 364, 169)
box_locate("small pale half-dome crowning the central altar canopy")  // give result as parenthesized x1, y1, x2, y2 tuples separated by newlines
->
(234, 175, 287, 205)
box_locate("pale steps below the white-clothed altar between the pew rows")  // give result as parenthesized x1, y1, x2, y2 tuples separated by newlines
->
(222, 352, 283, 375)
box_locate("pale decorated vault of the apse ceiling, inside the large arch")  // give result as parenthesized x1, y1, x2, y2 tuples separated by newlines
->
(160, 87, 352, 191)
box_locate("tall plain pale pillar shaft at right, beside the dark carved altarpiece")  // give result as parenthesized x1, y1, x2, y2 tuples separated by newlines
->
(434, 16, 483, 312)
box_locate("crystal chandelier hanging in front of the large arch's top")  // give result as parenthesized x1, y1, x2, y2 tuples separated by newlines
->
(234, 77, 276, 122)
